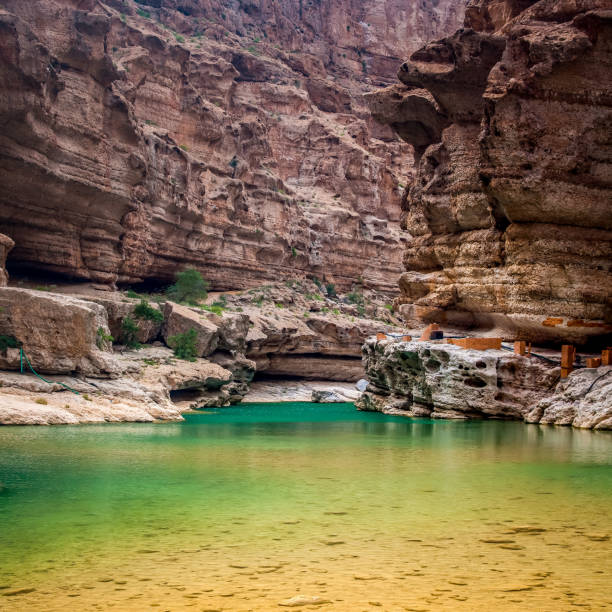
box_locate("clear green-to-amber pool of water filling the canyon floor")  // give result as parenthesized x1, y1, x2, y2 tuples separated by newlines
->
(0, 403, 612, 611)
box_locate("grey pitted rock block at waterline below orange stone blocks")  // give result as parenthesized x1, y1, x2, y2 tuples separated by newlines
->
(357, 338, 559, 420)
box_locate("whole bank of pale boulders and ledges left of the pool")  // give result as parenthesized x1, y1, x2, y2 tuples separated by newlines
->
(0, 281, 404, 424)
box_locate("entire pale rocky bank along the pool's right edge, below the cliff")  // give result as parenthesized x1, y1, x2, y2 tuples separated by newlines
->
(356, 338, 612, 429)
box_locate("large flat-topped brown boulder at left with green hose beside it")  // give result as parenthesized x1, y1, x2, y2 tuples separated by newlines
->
(0, 287, 118, 376)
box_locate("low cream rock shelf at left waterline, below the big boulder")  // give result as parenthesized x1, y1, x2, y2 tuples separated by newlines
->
(0, 347, 249, 425)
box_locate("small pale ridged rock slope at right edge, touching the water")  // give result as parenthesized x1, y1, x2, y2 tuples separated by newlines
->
(526, 366, 612, 429)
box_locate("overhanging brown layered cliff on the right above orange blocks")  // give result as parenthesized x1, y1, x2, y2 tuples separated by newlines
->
(369, 0, 612, 343)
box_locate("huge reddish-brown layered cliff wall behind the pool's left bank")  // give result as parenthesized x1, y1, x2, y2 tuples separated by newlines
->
(0, 0, 464, 291)
